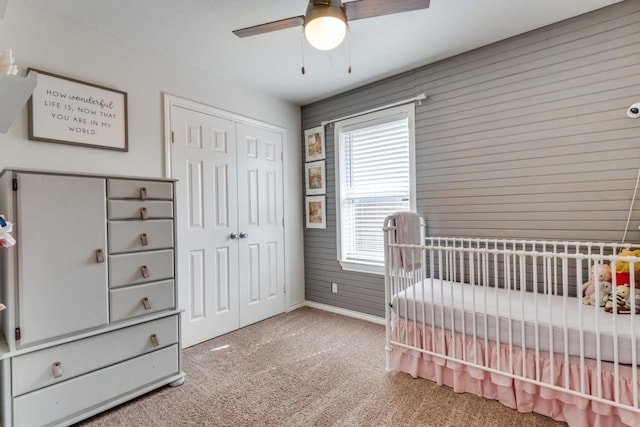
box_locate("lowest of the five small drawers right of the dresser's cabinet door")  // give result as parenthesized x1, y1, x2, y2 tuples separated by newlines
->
(109, 280, 175, 322)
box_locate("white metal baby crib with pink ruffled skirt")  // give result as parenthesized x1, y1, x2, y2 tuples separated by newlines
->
(384, 217, 640, 426)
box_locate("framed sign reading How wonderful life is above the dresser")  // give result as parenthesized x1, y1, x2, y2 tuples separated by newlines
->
(29, 69, 129, 151)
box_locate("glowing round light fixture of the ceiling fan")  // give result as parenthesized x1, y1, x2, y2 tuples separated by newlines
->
(304, 0, 347, 50)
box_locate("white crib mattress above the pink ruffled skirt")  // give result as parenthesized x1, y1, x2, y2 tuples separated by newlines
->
(391, 278, 640, 364)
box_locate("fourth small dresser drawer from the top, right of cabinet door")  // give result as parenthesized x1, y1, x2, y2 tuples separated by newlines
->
(109, 249, 173, 288)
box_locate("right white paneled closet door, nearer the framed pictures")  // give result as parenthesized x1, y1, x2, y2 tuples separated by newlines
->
(237, 124, 285, 327)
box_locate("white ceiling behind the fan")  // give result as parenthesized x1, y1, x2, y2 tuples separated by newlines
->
(18, 0, 621, 105)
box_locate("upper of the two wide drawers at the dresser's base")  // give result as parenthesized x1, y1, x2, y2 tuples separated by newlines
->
(12, 316, 178, 396)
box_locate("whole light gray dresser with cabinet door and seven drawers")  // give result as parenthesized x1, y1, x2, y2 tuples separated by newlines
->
(0, 170, 184, 427)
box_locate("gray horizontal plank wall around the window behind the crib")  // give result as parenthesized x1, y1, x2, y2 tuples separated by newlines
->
(301, 0, 640, 316)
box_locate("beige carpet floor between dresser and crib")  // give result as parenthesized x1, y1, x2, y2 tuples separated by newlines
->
(79, 308, 565, 427)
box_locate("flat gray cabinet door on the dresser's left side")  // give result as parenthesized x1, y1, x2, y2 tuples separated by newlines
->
(15, 173, 109, 346)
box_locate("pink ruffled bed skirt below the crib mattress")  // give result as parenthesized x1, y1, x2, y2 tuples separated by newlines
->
(391, 319, 640, 427)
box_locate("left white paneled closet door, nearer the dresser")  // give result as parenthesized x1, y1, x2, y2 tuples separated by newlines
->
(171, 107, 239, 347)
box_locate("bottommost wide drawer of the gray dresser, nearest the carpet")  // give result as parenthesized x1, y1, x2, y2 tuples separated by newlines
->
(13, 345, 179, 427)
